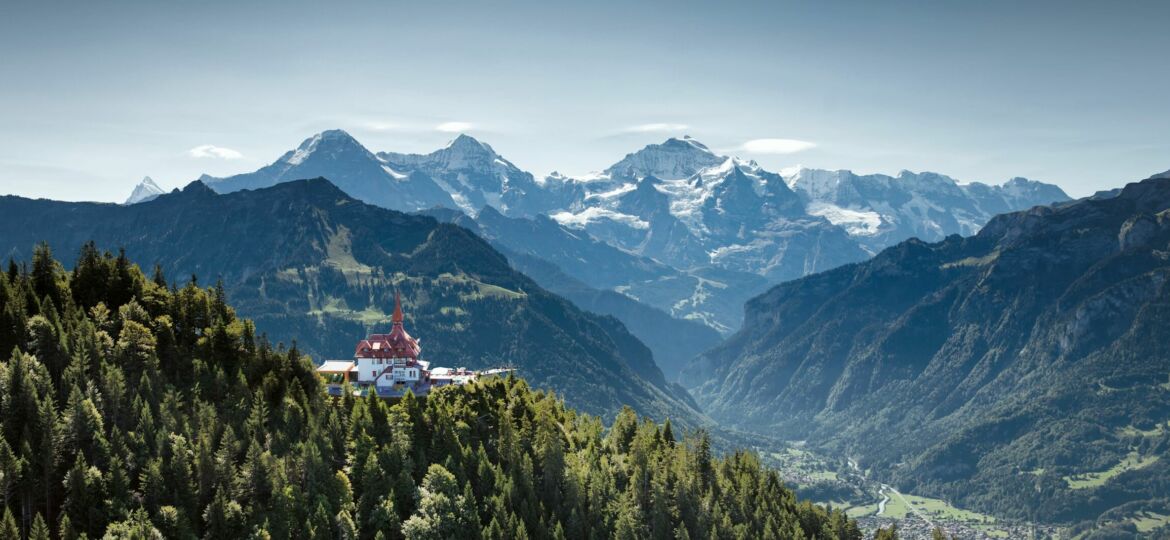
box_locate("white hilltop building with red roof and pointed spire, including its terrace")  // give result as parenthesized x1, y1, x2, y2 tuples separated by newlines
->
(317, 292, 509, 399)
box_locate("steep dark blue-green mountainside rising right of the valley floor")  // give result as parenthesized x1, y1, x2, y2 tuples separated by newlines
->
(683, 179, 1170, 521)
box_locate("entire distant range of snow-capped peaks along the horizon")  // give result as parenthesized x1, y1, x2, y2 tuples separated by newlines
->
(184, 130, 1068, 333)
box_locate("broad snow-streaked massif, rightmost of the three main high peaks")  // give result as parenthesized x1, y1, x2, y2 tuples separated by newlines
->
(526, 138, 866, 282)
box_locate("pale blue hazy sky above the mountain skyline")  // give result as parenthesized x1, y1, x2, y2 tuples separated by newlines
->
(0, 0, 1170, 201)
